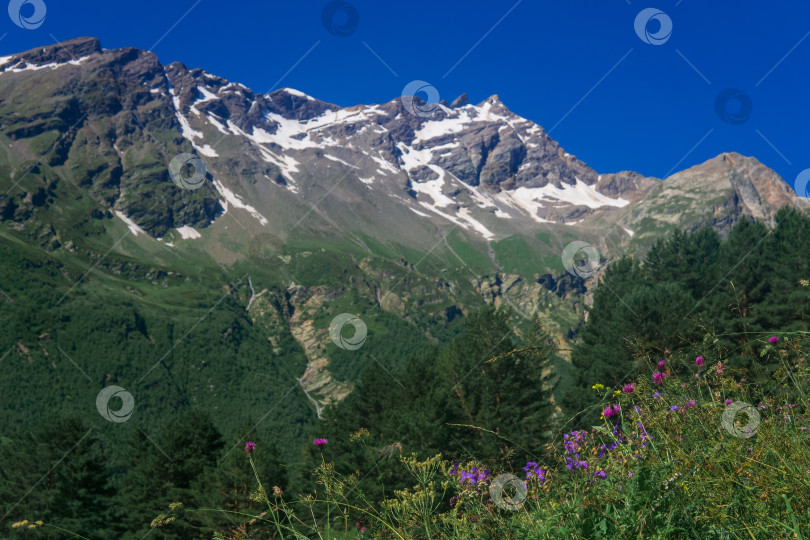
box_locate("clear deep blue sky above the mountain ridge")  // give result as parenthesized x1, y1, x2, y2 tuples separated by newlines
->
(0, 0, 810, 191)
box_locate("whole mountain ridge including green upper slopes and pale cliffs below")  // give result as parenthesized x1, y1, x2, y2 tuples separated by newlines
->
(0, 38, 806, 406)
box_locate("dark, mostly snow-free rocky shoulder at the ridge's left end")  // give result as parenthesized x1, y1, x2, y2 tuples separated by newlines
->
(0, 34, 222, 237)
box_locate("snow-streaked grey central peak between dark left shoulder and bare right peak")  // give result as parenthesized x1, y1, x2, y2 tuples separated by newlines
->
(166, 53, 657, 239)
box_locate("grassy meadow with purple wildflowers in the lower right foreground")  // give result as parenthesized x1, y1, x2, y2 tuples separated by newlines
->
(174, 332, 810, 539)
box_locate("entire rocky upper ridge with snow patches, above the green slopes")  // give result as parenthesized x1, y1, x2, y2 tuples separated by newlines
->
(0, 38, 801, 249)
